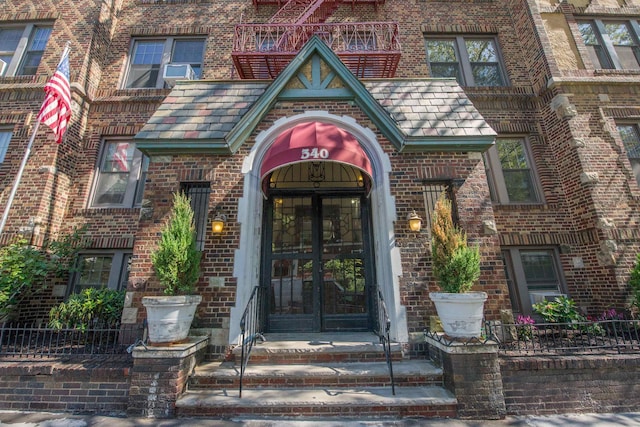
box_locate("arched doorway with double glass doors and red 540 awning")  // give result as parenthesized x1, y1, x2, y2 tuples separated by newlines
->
(260, 122, 375, 332)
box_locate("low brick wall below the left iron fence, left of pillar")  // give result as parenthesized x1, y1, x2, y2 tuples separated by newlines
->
(0, 356, 133, 415)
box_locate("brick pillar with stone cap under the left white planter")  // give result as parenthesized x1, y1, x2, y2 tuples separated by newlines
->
(127, 337, 209, 418)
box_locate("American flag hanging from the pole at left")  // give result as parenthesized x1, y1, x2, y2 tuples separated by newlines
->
(38, 49, 71, 144)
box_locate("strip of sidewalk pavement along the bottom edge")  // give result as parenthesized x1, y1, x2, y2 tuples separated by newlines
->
(0, 411, 640, 427)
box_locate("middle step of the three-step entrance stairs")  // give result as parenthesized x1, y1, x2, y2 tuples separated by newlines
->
(189, 359, 442, 390)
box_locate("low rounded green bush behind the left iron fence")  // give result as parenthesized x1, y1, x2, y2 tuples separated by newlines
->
(49, 288, 125, 331)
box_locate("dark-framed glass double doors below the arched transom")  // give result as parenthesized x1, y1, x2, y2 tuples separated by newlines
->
(263, 194, 373, 332)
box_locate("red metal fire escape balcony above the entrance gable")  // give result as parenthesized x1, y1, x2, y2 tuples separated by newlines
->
(231, 22, 401, 78)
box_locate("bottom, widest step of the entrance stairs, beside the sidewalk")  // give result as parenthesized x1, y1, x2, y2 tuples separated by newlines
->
(176, 386, 457, 418)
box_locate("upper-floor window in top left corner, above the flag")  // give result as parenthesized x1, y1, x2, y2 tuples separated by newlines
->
(0, 24, 51, 76)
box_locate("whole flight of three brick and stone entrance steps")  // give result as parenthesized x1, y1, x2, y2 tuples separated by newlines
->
(176, 333, 457, 418)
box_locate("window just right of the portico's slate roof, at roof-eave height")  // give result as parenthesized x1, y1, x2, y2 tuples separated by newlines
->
(484, 137, 541, 204)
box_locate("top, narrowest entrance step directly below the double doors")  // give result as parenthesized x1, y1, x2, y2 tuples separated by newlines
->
(233, 332, 402, 364)
